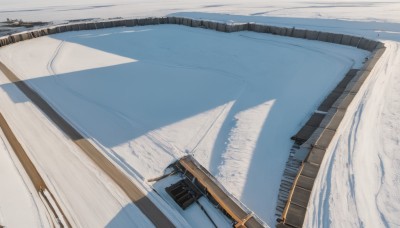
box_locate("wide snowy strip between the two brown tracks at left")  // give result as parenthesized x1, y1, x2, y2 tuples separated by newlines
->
(0, 65, 152, 227)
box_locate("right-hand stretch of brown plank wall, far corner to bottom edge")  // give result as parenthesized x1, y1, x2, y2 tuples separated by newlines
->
(277, 39, 386, 228)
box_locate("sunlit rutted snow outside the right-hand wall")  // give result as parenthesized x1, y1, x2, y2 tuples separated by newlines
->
(305, 42, 400, 227)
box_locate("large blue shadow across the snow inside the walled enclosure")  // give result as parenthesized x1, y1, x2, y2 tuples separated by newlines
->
(2, 18, 368, 224)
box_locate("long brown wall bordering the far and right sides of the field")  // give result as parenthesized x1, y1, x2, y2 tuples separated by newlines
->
(0, 17, 386, 227)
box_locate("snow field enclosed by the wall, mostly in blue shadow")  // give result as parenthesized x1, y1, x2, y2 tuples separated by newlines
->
(0, 25, 368, 224)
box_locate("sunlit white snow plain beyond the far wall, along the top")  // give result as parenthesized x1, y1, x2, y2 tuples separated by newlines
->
(0, 0, 400, 22)
